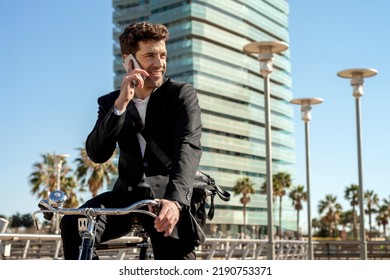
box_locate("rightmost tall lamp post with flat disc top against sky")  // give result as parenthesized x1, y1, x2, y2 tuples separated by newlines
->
(337, 68, 378, 260)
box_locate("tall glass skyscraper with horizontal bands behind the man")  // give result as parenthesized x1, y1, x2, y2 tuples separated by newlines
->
(113, 0, 296, 237)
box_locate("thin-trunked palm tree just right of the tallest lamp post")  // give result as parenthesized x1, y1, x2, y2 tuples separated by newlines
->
(261, 172, 291, 239)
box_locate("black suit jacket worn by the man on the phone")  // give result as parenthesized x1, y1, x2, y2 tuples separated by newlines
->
(86, 78, 202, 206)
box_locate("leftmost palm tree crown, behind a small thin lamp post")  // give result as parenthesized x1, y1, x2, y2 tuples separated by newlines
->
(29, 153, 78, 207)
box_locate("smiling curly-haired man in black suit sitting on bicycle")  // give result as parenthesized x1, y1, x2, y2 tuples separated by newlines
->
(61, 22, 202, 260)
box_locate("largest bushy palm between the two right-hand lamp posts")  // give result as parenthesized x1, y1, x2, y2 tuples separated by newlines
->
(318, 194, 342, 237)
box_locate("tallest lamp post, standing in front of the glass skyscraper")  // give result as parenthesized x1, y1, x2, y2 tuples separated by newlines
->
(244, 41, 288, 260)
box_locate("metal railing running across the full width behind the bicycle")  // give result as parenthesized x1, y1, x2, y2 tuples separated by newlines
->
(0, 233, 390, 260)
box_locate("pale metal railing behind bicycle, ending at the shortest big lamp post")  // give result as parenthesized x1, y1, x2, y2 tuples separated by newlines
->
(0, 233, 307, 260)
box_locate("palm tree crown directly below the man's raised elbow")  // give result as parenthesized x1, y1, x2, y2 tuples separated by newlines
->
(75, 148, 118, 197)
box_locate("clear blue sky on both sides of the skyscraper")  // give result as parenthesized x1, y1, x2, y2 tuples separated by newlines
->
(0, 0, 390, 228)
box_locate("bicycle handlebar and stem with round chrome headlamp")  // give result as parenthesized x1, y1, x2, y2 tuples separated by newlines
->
(32, 191, 160, 260)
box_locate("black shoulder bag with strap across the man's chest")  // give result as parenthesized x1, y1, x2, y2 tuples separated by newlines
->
(128, 101, 230, 246)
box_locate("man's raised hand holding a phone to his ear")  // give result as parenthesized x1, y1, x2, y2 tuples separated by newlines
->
(115, 54, 149, 112)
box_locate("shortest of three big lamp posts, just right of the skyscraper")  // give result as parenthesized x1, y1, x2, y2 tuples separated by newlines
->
(290, 98, 324, 260)
